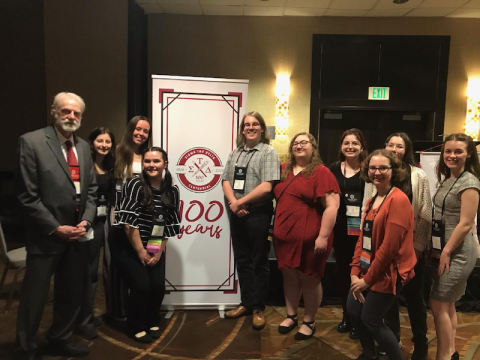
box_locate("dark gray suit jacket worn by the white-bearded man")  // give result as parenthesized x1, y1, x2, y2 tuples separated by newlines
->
(15, 125, 97, 254)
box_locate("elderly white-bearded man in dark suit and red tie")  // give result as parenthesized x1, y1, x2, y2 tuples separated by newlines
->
(14, 92, 97, 359)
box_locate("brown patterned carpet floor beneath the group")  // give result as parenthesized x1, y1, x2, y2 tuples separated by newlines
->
(0, 264, 480, 360)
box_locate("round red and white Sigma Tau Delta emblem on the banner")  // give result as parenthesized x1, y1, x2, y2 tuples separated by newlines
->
(175, 148, 223, 192)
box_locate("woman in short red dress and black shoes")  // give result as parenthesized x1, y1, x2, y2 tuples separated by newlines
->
(273, 133, 340, 340)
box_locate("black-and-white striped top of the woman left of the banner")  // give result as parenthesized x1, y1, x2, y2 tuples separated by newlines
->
(115, 177, 180, 247)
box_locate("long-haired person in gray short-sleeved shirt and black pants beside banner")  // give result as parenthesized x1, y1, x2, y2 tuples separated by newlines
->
(223, 111, 280, 330)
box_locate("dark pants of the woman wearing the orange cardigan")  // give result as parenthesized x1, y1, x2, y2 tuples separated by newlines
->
(347, 281, 403, 360)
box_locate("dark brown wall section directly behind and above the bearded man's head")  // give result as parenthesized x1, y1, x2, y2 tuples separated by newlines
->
(44, 0, 128, 141)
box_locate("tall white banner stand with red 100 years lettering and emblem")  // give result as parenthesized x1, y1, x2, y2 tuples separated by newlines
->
(152, 75, 248, 310)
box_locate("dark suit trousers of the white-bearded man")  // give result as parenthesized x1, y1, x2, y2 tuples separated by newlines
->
(17, 241, 88, 352)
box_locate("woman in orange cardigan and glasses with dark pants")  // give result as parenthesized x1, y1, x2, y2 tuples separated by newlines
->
(347, 149, 417, 360)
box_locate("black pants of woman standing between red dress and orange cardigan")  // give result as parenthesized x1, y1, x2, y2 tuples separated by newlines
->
(333, 231, 358, 320)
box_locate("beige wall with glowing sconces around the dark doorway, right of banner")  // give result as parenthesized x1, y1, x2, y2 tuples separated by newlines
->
(149, 15, 480, 147)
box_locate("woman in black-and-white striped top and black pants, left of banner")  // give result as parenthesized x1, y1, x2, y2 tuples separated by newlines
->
(112, 147, 180, 343)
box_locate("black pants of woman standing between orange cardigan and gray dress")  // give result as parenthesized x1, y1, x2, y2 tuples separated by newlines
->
(385, 258, 428, 349)
